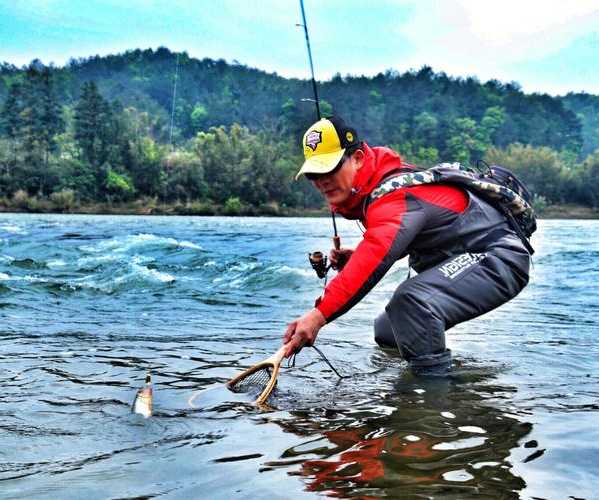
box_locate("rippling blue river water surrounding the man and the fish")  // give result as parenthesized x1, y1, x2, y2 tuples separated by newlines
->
(0, 214, 599, 499)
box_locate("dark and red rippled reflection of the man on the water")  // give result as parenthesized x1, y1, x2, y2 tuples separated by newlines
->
(263, 369, 538, 498)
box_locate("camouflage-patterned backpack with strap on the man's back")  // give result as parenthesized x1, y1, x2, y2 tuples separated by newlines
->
(368, 163, 537, 255)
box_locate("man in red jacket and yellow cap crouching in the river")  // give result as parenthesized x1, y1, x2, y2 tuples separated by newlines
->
(283, 117, 530, 375)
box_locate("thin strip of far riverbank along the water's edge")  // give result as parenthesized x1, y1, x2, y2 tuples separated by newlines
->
(0, 201, 599, 219)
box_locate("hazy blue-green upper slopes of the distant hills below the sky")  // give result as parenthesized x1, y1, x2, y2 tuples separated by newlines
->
(0, 48, 599, 156)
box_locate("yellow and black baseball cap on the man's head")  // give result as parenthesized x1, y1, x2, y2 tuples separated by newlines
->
(295, 116, 360, 179)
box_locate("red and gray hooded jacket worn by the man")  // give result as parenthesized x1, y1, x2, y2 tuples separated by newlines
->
(316, 143, 469, 321)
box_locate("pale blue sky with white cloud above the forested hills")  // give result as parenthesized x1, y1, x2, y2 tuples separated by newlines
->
(0, 0, 599, 95)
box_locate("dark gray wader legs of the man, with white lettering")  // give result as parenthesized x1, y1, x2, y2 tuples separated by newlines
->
(374, 235, 530, 376)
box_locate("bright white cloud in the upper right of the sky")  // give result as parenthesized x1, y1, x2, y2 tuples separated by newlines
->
(398, 0, 599, 91)
